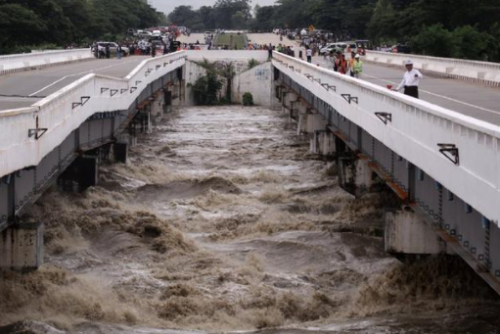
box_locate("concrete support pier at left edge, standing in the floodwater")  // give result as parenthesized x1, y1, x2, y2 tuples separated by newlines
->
(0, 223, 43, 272)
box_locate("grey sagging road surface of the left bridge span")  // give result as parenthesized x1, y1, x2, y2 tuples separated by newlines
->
(0, 56, 148, 111)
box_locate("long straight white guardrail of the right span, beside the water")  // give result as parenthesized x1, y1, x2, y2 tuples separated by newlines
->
(273, 52, 500, 226)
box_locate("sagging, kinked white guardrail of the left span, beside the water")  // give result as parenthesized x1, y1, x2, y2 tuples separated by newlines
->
(0, 51, 186, 177)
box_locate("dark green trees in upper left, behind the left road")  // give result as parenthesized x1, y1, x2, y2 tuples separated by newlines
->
(0, 0, 167, 54)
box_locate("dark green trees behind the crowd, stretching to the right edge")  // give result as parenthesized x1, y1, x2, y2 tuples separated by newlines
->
(168, 0, 500, 61)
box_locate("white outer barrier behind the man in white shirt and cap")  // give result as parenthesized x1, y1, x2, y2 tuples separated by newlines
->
(365, 51, 500, 86)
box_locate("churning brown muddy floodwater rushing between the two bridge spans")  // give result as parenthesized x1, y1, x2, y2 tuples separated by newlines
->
(0, 107, 500, 334)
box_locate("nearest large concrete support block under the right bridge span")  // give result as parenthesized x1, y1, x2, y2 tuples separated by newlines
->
(385, 211, 452, 255)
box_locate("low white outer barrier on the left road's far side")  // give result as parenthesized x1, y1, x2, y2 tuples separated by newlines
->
(0, 49, 94, 75)
